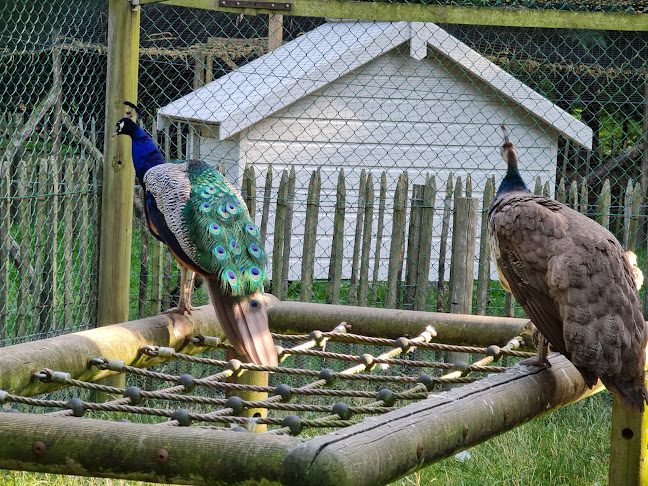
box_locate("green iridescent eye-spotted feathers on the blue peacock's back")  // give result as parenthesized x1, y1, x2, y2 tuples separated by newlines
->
(182, 162, 267, 296)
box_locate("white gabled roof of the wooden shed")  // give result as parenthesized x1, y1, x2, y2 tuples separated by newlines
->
(158, 21, 592, 148)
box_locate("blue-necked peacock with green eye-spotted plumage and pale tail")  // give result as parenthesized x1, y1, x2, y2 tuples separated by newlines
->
(113, 102, 277, 366)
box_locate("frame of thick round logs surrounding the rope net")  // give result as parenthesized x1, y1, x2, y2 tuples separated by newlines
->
(0, 297, 602, 486)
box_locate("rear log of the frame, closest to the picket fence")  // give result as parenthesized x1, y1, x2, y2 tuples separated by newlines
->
(268, 301, 532, 349)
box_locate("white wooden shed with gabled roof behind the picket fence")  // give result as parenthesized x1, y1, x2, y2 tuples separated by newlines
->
(158, 21, 592, 279)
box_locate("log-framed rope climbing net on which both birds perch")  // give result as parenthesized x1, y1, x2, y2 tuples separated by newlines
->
(0, 302, 604, 485)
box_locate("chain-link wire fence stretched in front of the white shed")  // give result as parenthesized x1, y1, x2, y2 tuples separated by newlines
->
(0, 0, 648, 345)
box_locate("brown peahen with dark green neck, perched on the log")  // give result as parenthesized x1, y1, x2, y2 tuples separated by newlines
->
(488, 126, 648, 412)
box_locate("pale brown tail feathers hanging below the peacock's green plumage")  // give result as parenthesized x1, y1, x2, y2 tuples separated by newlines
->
(207, 279, 278, 366)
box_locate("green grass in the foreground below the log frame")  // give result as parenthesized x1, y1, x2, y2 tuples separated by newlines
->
(0, 391, 612, 486)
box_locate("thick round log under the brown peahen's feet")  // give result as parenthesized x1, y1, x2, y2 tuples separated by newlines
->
(282, 353, 602, 486)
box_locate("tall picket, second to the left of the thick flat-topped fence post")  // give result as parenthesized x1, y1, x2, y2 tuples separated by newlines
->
(414, 174, 436, 310)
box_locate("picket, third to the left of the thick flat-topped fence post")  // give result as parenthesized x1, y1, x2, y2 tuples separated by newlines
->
(403, 184, 425, 309)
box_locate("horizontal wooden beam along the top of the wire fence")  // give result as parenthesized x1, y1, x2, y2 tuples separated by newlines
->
(151, 0, 648, 31)
